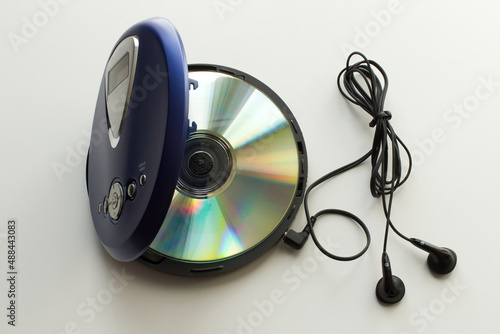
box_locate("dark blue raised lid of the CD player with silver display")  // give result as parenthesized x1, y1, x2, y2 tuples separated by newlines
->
(87, 18, 189, 261)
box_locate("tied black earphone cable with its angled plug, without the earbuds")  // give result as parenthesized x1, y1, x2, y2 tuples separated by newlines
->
(285, 52, 412, 261)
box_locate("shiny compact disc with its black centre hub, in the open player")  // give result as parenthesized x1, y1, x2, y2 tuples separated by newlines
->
(139, 66, 306, 271)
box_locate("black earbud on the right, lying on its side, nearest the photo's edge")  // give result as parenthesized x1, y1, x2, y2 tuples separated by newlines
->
(410, 238, 457, 275)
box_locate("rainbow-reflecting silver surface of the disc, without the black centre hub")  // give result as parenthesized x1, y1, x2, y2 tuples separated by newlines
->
(146, 71, 299, 262)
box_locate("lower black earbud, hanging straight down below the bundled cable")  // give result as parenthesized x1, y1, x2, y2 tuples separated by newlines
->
(375, 252, 405, 304)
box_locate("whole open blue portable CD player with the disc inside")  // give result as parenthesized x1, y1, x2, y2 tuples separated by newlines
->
(86, 18, 307, 276)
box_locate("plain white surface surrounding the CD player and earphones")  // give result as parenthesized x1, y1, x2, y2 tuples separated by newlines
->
(0, 0, 500, 334)
